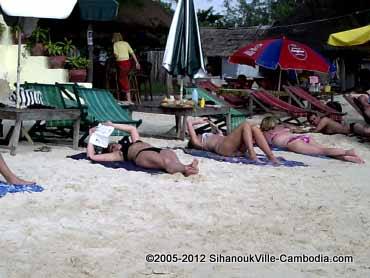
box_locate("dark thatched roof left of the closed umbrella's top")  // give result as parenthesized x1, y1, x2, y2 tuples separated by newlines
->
(116, 0, 172, 29)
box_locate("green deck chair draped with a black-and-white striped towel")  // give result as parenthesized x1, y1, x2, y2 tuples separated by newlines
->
(21, 82, 77, 140)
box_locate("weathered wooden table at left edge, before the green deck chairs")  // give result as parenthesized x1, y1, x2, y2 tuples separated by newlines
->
(0, 107, 81, 155)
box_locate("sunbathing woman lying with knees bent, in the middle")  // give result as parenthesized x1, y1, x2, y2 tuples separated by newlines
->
(187, 119, 279, 164)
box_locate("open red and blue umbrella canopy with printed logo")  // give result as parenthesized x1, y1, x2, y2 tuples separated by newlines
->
(229, 37, 329, 72)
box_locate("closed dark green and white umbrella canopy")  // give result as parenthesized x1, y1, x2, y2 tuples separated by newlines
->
(162, 0, 204, 78)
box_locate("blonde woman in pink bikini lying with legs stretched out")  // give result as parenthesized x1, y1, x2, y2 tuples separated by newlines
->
(261, 117, 364, 163)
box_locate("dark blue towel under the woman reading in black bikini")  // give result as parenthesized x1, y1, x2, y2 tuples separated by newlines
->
(67, 153, 164, 174)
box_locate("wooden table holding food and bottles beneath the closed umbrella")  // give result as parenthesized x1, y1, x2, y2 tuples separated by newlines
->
(130, 101, 231, 140)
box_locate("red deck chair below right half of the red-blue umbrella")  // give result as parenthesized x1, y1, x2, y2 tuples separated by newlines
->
(283, 85, 345, 122)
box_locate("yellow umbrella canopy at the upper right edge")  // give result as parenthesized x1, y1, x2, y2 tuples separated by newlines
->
(328, 25, 370, 46)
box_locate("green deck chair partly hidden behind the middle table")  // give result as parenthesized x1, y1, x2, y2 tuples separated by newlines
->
(186, 87, 246, 130)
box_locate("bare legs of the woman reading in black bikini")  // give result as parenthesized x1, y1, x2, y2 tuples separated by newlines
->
(135, 150, 199, 176)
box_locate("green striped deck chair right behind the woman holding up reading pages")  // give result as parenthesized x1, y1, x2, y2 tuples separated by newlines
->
(74, 86, 142, 139)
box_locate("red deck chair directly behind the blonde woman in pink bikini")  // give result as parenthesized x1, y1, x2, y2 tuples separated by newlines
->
(250, 89, 309, 124)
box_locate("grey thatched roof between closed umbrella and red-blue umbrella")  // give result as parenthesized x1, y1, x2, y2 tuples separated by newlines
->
(200, 26, 268, 57)
